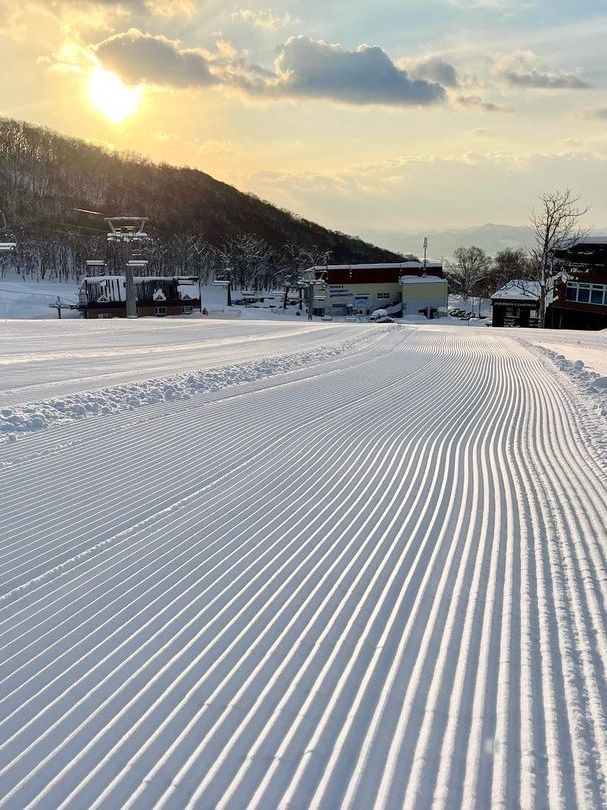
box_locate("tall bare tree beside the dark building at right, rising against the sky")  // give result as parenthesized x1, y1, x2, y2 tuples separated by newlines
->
(531, 188, 589, 327)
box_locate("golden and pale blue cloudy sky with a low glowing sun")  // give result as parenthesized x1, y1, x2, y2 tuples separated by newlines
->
(0, 0, 607, 236)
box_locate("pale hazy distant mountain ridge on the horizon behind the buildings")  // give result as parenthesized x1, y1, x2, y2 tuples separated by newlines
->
(362, 223, 532, 259)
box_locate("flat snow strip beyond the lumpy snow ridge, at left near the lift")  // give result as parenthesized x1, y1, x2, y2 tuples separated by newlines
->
(0, 318, 369, 406)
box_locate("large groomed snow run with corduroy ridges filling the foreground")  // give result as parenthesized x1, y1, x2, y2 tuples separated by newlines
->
(0, 324, 607, 810)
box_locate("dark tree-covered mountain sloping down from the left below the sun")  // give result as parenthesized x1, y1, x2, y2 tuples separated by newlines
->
(0, 118, 400, 276)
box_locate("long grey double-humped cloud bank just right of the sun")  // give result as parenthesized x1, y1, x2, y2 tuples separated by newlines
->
(96, 28, 446, 106)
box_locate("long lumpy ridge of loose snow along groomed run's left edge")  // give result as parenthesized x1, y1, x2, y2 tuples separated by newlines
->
(0, 332, 378, 443)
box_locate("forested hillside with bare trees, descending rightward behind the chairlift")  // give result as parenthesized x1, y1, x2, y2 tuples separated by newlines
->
(0, 118, 398, 281)
